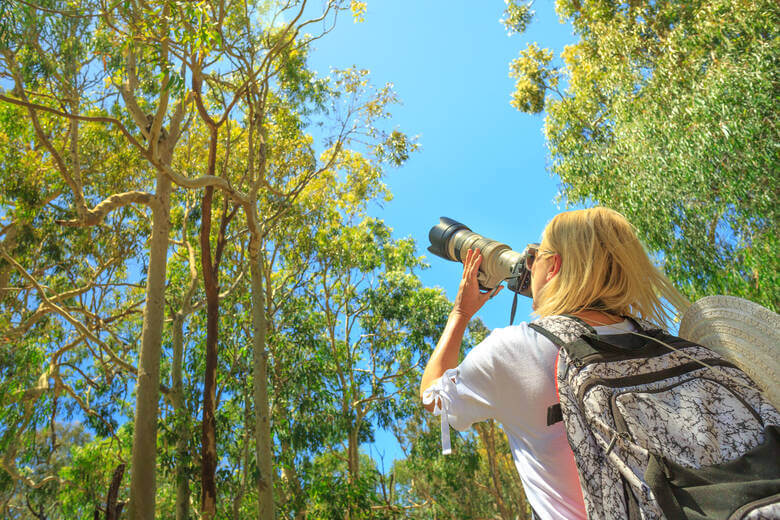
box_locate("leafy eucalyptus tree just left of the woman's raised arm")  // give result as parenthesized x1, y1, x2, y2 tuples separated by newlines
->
(290, 216, 447, 518)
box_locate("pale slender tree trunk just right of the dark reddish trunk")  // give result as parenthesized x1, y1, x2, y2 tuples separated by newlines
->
(249, 242, 274, 520)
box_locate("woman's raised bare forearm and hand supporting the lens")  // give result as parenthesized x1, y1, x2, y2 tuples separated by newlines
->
(420, 249, 503, 411)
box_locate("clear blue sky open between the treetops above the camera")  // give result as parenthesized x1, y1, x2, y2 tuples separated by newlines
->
(310, 0, 574, 469)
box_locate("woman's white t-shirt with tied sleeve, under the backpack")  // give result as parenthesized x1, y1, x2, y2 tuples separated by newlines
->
(423, 321, 634, 520)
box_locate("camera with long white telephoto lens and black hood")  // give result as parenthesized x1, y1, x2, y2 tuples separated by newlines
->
(428, 217, 538, 298)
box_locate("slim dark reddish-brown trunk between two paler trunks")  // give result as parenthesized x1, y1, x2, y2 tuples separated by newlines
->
(200, 186, 219, 520)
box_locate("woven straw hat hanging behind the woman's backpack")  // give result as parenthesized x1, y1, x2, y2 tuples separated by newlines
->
(679, 296, 780, 409)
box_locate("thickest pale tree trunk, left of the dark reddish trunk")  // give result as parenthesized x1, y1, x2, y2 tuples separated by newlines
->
(130, 173, 171, 520)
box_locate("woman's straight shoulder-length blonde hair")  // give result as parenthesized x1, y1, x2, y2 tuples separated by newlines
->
(534, 207, 690, 327)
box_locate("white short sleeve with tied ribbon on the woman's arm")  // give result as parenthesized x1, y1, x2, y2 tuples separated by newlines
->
(423, 337, 506, 455)
